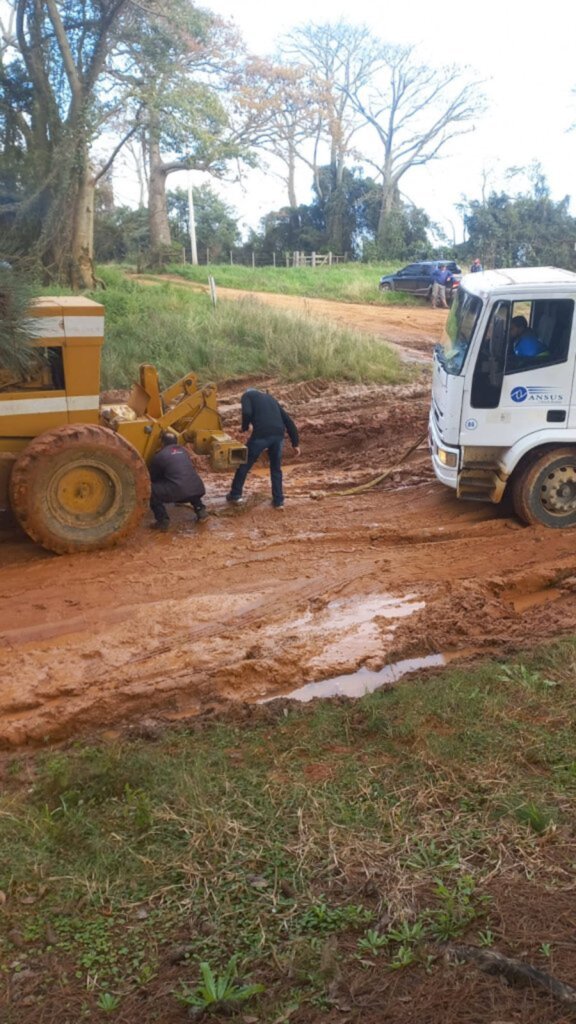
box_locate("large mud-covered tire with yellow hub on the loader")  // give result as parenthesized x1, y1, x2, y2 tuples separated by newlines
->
(10, 423, 150, 555)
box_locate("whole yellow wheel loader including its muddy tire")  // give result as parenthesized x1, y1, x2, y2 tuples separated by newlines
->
(0, 297, 246, 554)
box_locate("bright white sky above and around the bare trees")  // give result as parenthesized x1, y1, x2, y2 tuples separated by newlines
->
(112, 0, 576, 241)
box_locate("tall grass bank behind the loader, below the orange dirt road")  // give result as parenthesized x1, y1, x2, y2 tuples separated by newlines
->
(87, 268, 407, 388)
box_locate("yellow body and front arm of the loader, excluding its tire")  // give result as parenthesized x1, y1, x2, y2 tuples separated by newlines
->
(0, 297, 246, 509)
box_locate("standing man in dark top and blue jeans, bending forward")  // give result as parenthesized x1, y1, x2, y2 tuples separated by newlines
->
(227, 387, 300, 509)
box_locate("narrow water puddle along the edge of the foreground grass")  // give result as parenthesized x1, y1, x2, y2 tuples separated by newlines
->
(259, 654, 444, 703)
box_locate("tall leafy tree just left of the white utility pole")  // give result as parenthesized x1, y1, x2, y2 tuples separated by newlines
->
(117, 0, 259, 259)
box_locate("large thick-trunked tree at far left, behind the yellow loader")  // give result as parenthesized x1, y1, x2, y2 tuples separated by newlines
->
(0, 0, 143, 288)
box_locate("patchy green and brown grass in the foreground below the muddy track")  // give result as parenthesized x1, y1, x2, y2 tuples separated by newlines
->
(0, 641, 576, 1024)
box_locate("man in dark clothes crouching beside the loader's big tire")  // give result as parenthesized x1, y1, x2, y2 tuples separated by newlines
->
(150, 432, 208, 532)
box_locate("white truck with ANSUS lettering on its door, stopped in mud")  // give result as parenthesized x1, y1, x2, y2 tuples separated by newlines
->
(429, 267, 576, 527)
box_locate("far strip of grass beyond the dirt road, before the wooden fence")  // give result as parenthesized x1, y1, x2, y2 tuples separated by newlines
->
(163, 263, 414, 306)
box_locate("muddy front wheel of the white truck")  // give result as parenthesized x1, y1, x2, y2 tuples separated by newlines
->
(512, 447, 576, 529)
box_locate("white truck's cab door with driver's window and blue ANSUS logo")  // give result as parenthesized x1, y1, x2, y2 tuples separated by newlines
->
(460, 299, 574, 447)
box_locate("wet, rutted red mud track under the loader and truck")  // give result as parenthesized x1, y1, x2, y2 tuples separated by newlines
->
(0, 292, 576, 746)
